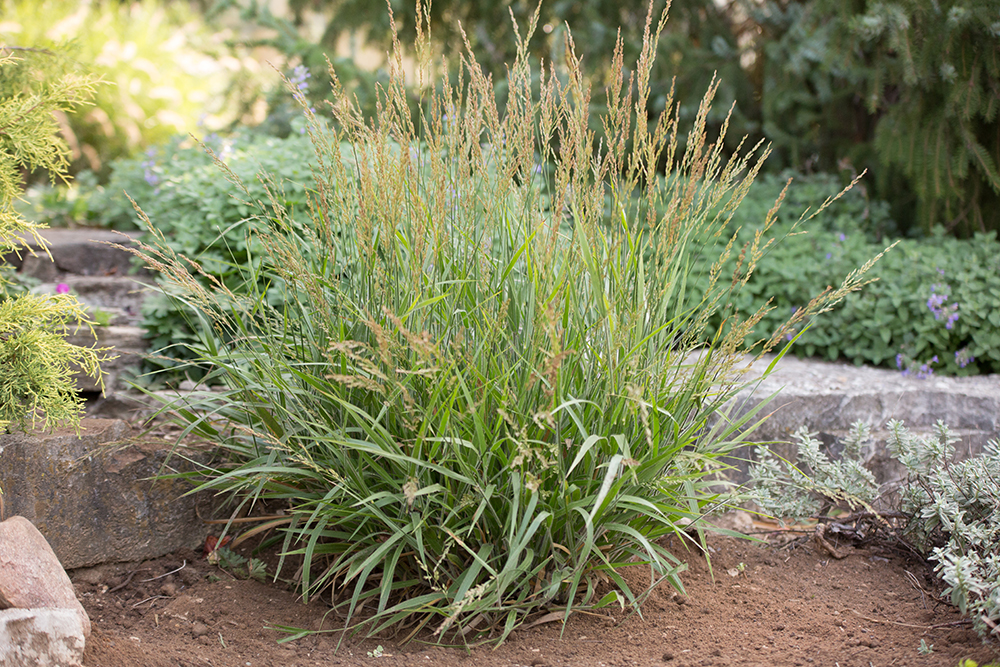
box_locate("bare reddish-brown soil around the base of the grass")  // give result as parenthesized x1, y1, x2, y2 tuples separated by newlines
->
(71, 537, 1000, 667)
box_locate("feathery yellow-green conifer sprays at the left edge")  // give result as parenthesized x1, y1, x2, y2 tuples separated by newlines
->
(0, 47, 104, 429)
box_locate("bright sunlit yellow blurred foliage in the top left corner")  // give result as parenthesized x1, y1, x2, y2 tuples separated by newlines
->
(0, 0, 277, 179)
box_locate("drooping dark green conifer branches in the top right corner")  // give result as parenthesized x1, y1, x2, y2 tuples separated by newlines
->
(833, 0, 1000, 233)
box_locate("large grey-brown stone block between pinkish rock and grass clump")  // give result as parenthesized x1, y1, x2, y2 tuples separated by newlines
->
(0, 419, 211, 569)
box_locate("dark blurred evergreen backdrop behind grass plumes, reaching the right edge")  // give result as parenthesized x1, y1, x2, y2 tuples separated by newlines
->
(221, 0, 1000, 236)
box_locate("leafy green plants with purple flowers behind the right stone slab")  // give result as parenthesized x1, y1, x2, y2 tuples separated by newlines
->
(704, 218, 1000, 377)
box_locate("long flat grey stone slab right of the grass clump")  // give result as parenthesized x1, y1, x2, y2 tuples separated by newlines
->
(732, 356, 1000, 482)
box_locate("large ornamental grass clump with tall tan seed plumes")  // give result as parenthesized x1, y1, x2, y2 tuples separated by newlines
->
(135, 2, 884, 643)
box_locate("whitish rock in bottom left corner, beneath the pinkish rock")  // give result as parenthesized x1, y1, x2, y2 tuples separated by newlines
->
(0, 609, 86, 667)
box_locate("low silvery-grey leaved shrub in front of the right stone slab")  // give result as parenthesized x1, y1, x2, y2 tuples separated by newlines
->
(750, 421, 1000, 637)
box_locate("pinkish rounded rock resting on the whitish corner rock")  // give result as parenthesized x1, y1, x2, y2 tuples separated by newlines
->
(0, 516, 90, 636)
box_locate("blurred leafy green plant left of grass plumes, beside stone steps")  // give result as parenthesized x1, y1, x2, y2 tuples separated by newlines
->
(87, 125, 315, 374)
